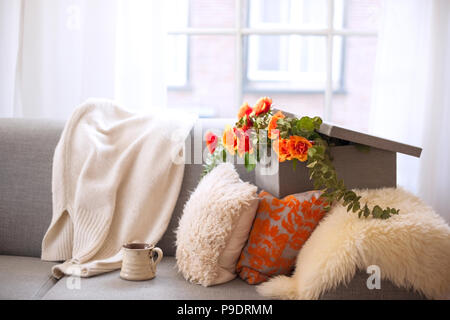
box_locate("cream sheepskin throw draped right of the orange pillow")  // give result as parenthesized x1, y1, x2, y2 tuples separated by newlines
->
(257, 188, 450, 299)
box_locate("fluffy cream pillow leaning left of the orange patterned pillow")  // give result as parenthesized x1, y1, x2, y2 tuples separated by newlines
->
(176, 163, 258, 286)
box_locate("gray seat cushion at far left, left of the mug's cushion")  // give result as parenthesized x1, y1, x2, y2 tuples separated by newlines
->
(0, 255, 56, 300)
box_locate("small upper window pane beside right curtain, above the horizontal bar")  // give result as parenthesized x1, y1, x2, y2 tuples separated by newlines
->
(334, 0, 381, 31)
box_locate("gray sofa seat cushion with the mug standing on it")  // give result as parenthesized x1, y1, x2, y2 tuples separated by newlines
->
(43, 257, 264, 300)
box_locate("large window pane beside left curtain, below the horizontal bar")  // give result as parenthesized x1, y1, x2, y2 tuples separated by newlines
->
(168, 35, 237, 117)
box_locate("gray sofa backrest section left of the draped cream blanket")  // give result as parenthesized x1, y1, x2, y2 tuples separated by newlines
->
(0, 119, 63, 257)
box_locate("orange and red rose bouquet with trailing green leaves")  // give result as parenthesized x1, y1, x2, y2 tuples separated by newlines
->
(204, 97, 399, 219)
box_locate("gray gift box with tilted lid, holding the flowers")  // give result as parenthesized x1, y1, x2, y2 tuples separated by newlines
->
(255, 117, 422, 197)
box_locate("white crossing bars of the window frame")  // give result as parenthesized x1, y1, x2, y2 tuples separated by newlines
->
(168, 0, 378, 121)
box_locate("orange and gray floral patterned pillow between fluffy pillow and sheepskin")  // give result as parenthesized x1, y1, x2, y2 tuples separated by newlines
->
(236, 191, 326, 284)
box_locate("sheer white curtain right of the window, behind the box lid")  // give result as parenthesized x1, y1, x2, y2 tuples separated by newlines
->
(371, 0, 450, 222)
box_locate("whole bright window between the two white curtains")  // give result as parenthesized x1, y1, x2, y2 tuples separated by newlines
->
(168, 0, 381, 129)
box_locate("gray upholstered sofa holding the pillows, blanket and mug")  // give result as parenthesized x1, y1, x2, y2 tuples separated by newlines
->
(0, 119, 422, 300)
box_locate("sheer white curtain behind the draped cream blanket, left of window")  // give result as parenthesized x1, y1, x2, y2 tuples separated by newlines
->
(0, 0, 166, 118)
